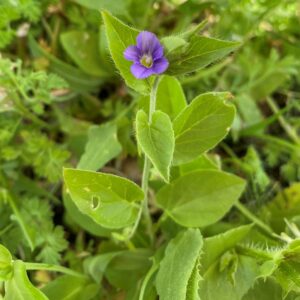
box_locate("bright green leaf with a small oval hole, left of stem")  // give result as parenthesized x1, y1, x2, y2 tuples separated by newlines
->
(64, 169, 144, 229)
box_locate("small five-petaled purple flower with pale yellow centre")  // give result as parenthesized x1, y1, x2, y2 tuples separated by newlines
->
(124, 31, 169, 79)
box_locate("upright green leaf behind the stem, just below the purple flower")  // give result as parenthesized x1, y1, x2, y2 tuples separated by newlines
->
(156, 75, 187, 120)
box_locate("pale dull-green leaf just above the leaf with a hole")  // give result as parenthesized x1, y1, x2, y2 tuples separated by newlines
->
(77, 123, 122, 171)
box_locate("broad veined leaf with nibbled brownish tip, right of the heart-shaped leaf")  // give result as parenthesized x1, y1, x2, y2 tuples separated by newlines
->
(173, 93, 235, 164)
